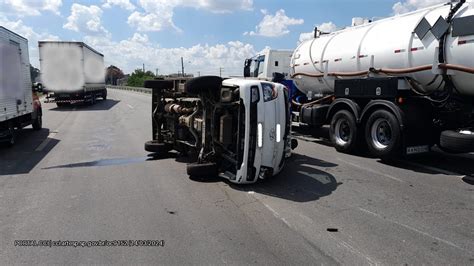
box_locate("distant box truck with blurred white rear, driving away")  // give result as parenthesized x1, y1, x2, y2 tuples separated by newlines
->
(38, 41, 107, 106)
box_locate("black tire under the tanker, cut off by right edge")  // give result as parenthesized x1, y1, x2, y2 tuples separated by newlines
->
(440, 130, 474, 153)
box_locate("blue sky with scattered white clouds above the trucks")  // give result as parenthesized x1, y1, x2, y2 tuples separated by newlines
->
(0, 0, 447, 75)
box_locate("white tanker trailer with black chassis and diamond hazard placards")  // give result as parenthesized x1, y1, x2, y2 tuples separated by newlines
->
(244, 0, 474, 158)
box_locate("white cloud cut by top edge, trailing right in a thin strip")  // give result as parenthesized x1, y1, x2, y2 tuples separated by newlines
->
(128, 0, 253, 31)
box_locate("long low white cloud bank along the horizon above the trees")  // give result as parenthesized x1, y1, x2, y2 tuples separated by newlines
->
(85, 33, 256, 76)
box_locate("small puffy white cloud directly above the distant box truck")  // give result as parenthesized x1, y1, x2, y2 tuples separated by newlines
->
(63, 4, 109, 35)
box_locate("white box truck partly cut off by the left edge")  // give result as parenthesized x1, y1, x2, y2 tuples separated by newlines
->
(0, 26, 42, 145)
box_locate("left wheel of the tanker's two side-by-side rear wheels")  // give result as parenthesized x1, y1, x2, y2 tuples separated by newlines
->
(329, 110, 357, 153)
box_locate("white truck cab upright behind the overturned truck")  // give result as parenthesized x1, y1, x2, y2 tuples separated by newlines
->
(244, 49, 293, 80)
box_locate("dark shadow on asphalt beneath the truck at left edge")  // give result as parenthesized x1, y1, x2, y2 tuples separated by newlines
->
(0, 128, 59, 176)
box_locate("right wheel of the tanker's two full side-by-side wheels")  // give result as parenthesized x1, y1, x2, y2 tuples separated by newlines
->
(365, 110, 402, 158)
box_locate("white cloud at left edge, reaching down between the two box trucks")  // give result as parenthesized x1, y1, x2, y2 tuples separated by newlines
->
(0, 16, 59, 68)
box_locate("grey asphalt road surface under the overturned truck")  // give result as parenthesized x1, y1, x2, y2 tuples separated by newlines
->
(0, 90, 474, 265)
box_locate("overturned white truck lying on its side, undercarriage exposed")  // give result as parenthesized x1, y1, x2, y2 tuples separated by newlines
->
(145, 76, 297, 184)
